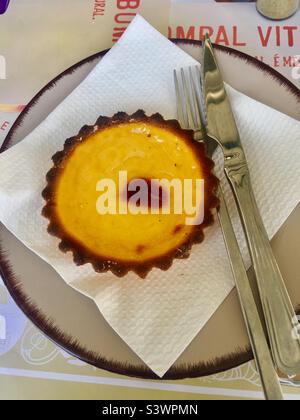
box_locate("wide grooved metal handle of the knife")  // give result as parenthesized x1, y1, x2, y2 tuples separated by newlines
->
(225, 166, 300, 376)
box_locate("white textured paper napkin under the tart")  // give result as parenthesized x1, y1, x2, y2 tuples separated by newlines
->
(0, 16, 300, 376)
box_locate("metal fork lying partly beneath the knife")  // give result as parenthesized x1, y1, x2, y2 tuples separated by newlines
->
(174, 66, 283, 400)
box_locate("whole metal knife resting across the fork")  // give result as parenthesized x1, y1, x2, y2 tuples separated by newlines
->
(202, 36, 300, 377)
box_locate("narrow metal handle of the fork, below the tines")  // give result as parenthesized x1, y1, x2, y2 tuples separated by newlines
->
(218, 187, 283, 401)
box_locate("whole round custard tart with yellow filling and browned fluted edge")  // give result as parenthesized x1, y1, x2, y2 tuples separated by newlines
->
(43, 112, 217, 277)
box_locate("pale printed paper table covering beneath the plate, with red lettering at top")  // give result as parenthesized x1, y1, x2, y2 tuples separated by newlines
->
(0, 0, 300, 400)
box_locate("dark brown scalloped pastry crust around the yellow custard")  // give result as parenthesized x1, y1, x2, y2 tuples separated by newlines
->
(42, 110, 219, 278)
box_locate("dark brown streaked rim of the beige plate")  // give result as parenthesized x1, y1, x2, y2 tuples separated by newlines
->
(0, 39, 300, 380)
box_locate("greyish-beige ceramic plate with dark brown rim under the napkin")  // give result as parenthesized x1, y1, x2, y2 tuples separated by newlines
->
(0, 41, 300, 379)
